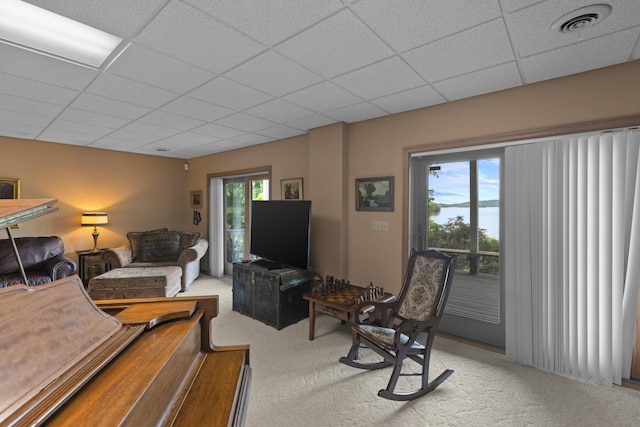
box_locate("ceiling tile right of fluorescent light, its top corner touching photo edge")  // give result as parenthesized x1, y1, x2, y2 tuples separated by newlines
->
(136, 2, 264, 73)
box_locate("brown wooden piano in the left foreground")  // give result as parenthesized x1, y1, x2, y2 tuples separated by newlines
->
(0, 200, 251, 427)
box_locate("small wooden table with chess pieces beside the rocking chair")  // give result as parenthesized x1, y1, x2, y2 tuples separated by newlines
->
(303, 285, 395, 340)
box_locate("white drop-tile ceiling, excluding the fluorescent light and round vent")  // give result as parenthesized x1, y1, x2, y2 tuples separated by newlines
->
(0, 0, 640, 159)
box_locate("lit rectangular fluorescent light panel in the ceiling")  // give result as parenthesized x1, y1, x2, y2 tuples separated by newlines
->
(0, 0, 122, 68)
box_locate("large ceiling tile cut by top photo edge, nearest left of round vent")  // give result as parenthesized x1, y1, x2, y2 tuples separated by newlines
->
(353, 0, 501, 52)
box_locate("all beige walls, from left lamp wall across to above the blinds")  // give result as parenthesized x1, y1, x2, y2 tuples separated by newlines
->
(0, 61, 640, 292)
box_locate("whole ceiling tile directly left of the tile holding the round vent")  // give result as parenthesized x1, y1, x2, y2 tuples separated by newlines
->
(402, 19, 514, 82)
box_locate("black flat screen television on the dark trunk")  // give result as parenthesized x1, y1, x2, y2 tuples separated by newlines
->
(249, 200, 311, 270)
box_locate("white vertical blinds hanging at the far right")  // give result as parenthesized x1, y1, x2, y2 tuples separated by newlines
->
(503, 131, 640, 385)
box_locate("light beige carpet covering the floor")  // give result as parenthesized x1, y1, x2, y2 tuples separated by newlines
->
(180, 276, 640, 427)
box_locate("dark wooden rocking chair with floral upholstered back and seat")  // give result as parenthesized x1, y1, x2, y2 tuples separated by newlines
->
(340, 249, 458, 400)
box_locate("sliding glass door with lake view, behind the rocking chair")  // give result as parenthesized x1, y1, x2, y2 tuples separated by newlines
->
(410, 151, 504, 348)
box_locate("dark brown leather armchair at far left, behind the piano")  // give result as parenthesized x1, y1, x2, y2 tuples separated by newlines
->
(0, 236, 77, 288)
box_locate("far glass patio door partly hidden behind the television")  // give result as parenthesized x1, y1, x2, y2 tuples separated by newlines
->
(223, 175, 269, 275)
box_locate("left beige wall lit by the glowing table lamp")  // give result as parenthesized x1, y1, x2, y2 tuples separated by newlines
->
(0, 137, 191, 258)
